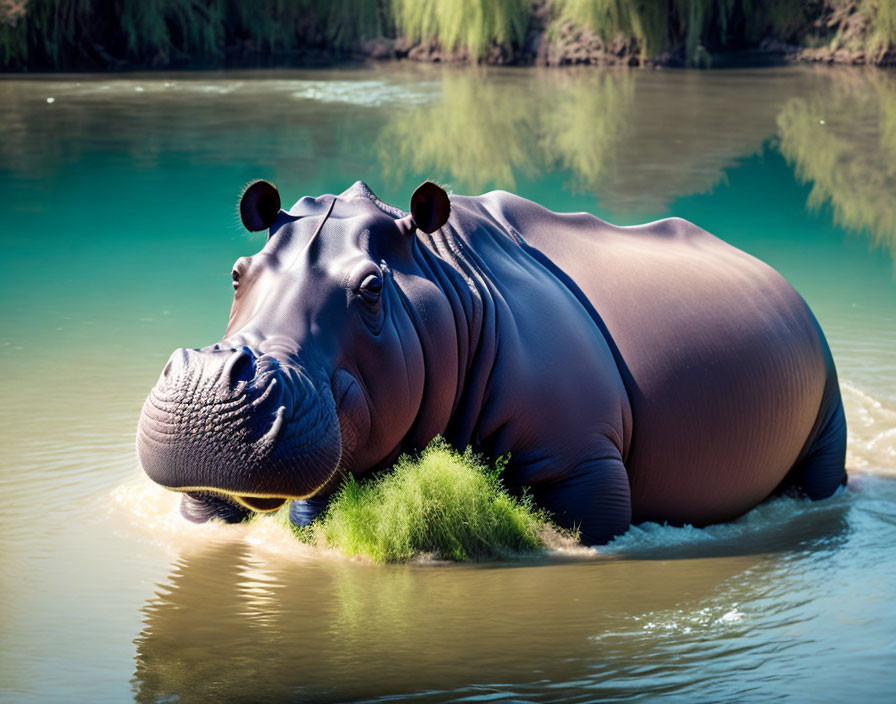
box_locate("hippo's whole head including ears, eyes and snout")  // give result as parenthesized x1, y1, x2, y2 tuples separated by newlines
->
(137, 181, 456, 511)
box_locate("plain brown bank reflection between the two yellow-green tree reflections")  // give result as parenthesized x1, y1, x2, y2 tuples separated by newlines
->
(594, 69, 811, 214)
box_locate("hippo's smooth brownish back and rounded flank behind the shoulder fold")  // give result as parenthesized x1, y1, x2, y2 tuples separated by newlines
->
(477, 192, 836, 523)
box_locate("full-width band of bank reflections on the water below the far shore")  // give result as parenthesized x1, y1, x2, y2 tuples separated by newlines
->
(0, 67, 896, 256)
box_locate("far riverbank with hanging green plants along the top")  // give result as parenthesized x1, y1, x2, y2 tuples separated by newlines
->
(0, 0, 896, 71)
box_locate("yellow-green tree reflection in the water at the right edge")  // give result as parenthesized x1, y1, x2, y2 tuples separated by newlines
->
(778, 70, 896, 255)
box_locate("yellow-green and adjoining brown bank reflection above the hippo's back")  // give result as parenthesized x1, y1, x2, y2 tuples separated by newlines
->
(377, 69, 804, 215)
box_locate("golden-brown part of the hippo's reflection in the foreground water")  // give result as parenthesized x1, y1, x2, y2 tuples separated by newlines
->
(134, 546, 748, 703)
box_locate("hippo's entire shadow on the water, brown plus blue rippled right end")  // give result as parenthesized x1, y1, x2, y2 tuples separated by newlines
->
(134, 484, 852, 703)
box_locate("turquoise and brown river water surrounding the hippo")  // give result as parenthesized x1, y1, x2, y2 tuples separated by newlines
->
(0, 65, 896, 702)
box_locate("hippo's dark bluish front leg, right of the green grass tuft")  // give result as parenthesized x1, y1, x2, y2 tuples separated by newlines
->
(532, 457, 632, 545)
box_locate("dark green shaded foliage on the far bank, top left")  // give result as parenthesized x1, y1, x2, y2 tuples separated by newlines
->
(0, 0, 392, 68)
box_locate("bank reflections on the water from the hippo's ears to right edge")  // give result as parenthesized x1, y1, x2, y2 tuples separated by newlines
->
(376, 64, 896, 254)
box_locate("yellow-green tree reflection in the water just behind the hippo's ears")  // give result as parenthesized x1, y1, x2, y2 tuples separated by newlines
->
(377, 71, 633, 193)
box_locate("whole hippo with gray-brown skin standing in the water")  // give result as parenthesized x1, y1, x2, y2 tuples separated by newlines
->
(137, 181, 846, 544)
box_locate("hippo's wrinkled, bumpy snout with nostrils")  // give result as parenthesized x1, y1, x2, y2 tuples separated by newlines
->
(137, 346, 341, 511)
